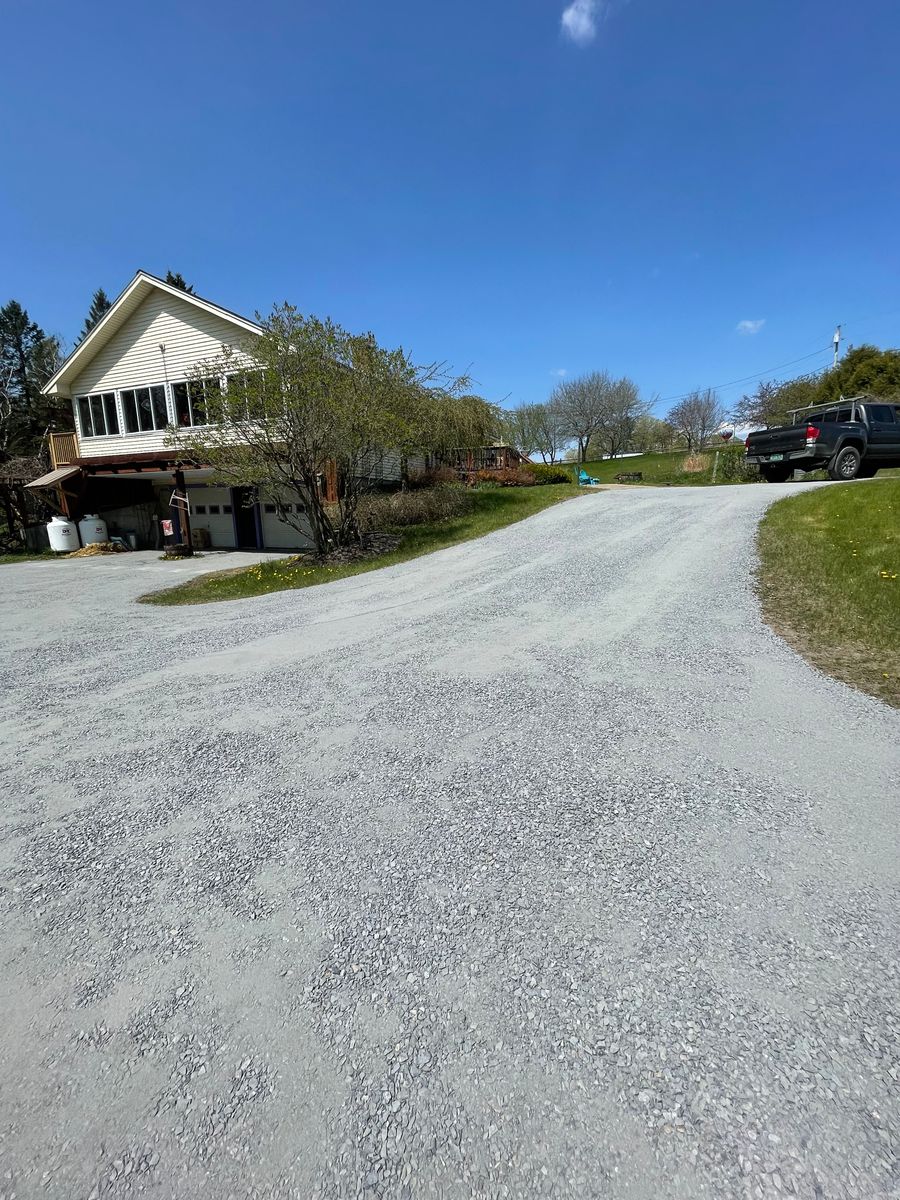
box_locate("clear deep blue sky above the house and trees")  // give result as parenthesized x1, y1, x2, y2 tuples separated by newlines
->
(0, 0, 900, 408)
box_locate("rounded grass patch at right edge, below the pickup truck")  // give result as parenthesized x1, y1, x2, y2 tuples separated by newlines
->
(760, 479, 900, 707)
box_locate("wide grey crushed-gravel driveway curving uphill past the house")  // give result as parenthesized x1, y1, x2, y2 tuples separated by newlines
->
(0, 487, 900, 1200)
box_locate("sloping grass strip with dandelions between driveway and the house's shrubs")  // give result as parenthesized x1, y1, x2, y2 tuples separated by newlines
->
(140, 484, 578, 605)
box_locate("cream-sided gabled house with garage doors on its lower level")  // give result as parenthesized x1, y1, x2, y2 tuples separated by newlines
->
(28, 271, 408, 550)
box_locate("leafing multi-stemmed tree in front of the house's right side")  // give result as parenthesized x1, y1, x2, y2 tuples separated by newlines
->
(170, 304, 499, 552)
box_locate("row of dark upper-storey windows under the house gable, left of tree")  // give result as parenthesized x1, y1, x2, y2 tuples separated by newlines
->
(76, 379, 222, 438)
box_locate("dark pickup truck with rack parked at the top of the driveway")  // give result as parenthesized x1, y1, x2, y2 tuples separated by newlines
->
(746, 397, 900, 484)
